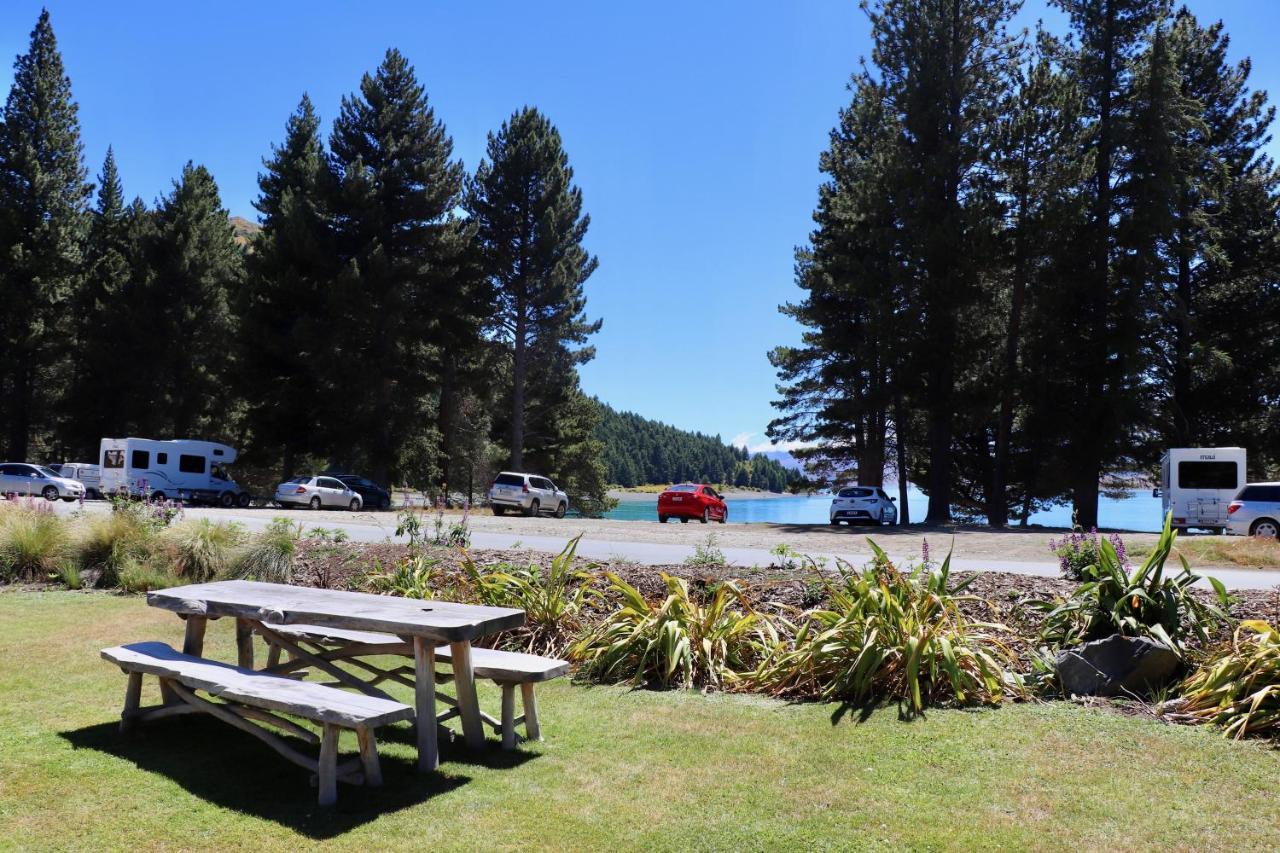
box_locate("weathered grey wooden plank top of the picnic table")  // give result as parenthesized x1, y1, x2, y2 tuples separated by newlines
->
(147, 580, 525, 643)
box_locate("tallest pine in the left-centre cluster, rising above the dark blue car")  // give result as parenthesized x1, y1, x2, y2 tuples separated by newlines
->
(329, 50, 485, 487)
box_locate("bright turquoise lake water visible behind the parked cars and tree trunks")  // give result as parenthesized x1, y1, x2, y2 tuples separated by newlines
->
(604, 487, 1164, 532)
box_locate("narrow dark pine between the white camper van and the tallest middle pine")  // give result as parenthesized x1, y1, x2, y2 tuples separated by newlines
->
(238, 95, 332, 479)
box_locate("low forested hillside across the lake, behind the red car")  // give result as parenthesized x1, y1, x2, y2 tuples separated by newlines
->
(596, 401, 791, 492)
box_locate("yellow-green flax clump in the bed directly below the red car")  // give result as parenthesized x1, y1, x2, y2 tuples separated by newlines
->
(570, 573, 777, 688)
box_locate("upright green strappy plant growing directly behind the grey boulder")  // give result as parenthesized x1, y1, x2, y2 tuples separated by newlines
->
(1037, 514, 1230, 654)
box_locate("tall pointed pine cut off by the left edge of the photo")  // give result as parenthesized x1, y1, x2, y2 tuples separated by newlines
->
(0, 10, 92, 460)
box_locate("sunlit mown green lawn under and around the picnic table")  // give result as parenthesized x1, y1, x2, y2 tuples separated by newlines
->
(0, 592, 1280, 852)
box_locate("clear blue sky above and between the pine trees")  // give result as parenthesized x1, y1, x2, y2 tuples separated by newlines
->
(0, 0, 1280, 447)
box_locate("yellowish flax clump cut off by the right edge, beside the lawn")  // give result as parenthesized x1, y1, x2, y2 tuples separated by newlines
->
(1161, 620, 1280, 738)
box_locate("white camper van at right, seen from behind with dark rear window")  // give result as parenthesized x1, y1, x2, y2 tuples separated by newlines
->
(1160, 447, 1245, 533)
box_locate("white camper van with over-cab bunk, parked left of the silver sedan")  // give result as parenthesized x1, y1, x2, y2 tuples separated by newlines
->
(99, 438, 250, 506)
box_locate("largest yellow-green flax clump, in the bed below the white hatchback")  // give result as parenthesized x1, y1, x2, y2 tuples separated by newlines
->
(746, 540, 1021, 716)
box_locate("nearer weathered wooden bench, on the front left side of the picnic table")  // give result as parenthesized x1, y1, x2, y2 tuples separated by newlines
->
(102, 643, 415, 806)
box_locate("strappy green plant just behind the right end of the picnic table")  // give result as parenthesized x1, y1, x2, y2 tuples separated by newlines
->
(462, 534, 591, 657)
